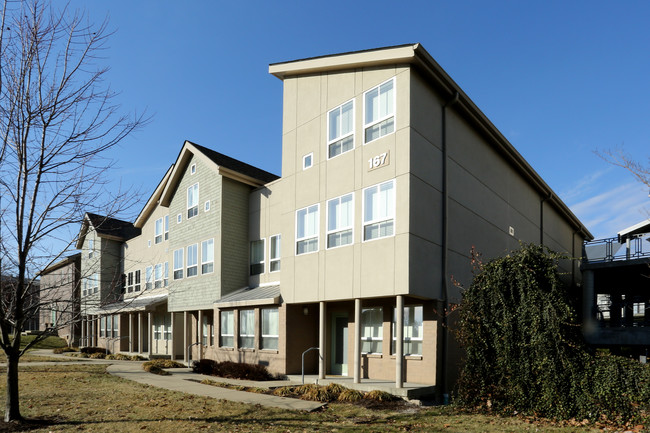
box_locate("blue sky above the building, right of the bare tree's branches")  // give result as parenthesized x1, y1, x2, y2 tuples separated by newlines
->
(71, 0, 650, 238)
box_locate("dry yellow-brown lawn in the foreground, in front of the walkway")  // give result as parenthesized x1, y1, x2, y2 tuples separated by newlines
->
(0, 365, 598, 432)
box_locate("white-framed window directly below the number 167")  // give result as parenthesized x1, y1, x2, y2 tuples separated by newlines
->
(363, 179, 395, 241)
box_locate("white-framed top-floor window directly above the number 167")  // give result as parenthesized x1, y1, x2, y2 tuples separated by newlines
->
(363, 78, 395, 143)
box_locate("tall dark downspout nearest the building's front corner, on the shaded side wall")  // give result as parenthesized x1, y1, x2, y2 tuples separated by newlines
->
(440, 92, 460, 403)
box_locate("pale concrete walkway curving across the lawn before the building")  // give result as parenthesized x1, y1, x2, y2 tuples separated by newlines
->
(29, 350, 324, 411)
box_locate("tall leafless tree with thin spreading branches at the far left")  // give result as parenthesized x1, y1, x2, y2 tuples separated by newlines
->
(0, 0, 144, 421)
